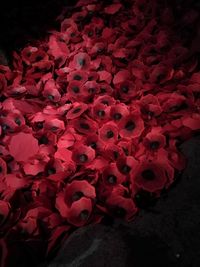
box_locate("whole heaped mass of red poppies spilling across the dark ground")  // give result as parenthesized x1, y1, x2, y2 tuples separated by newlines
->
(0, 0, 200, 266)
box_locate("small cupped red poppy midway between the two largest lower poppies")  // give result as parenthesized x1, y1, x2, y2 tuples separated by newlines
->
(102, 163, 125, 186)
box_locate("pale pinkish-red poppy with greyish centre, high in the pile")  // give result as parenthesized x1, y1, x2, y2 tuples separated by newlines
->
(69, 52, 90, 70)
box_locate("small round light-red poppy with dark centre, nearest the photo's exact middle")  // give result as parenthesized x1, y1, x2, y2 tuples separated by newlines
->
(98, 122, 118, 143)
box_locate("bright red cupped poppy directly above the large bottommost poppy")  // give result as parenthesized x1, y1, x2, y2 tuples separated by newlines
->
(72, 145, 95, 165)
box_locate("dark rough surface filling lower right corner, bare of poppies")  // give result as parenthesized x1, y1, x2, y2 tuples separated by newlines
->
(45, 138, 200, 267)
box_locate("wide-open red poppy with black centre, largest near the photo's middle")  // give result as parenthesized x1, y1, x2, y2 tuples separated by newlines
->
(118, 112, 144, 139)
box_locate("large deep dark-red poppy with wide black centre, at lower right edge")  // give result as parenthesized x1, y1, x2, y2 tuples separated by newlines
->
(131, 161, 170, 192)
